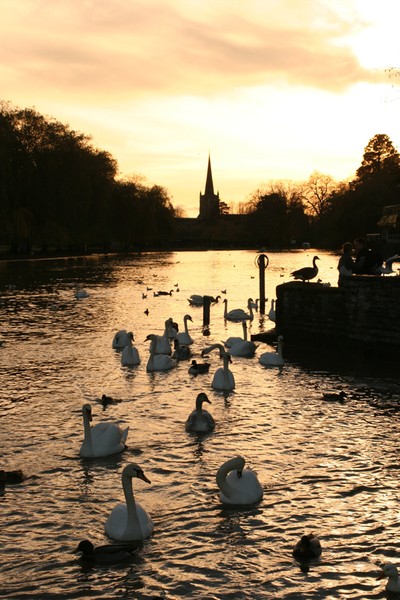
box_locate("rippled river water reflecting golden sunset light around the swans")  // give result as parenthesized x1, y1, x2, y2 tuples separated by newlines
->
(0, 250, 400, 600)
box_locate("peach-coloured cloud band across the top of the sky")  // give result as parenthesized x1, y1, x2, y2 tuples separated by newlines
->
(0, 0, 382, 105)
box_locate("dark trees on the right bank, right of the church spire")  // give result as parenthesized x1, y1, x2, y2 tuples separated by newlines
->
(240, 134, 400, 248)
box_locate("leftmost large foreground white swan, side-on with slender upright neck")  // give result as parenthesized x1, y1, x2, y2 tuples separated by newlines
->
(79, 404, 129, 458)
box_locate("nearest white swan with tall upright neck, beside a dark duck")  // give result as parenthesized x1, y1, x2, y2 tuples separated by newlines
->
(105, 463, 154, 541)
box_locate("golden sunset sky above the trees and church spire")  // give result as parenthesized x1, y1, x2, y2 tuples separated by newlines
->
(0, 0, 400, 217)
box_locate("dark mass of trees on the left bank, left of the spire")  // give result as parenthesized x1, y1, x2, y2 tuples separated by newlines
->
(0, 102, 174, 253)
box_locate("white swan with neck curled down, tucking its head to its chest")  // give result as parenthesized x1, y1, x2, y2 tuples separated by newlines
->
(216, 456, 263, 504)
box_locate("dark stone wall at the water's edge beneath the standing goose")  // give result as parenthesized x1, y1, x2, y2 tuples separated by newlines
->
(276, 275, 400, 355)
